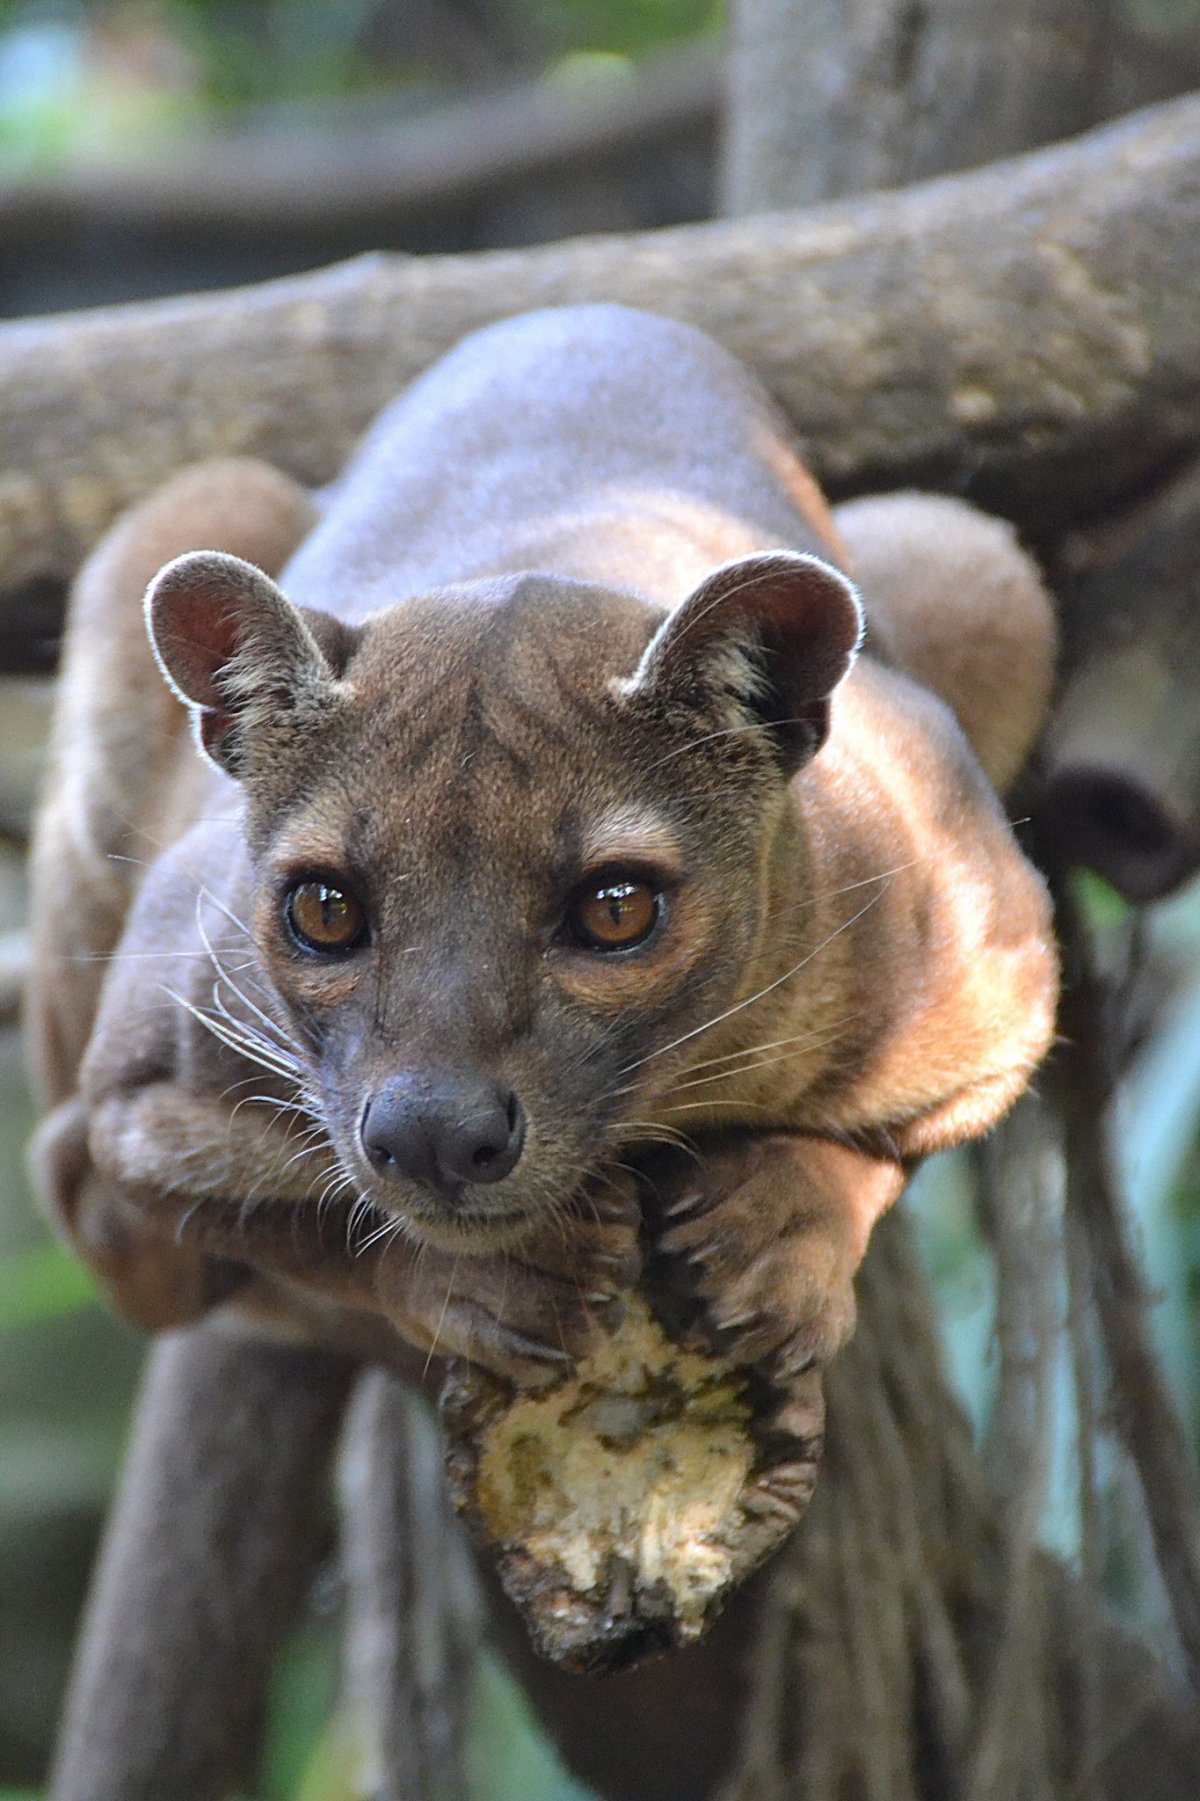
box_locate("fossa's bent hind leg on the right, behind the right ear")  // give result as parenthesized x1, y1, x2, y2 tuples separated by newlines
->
(834, 493, 1058, 792)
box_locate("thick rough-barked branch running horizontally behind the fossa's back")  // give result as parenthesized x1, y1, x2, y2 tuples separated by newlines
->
(0, 87, 1200, 608)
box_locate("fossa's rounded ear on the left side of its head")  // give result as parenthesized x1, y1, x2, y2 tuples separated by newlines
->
(146, 551, 341, 778)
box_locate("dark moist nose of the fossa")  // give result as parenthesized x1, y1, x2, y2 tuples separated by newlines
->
(360, 1072, 524, 1192)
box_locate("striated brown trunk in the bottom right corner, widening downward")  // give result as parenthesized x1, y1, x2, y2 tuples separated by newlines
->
(721, 1214, 1200, 1801)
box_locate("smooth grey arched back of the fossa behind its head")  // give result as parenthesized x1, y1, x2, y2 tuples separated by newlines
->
(283, 306, 838, 620)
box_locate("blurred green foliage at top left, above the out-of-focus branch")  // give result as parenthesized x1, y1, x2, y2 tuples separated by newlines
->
(0, 0, 724, 169)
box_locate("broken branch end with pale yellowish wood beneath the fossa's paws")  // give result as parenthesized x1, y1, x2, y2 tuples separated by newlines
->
(441, 1295, 825, 1675)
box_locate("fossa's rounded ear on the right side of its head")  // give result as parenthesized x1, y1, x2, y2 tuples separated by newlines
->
(623, 551, 863, 773)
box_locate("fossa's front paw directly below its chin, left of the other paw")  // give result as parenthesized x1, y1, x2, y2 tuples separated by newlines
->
(377, 1176, 641, 1389)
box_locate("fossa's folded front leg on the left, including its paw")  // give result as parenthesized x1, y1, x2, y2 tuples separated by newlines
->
(78, 1082, 640, 1385)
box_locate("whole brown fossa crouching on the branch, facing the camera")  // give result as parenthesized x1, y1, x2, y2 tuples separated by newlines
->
(32, 306, 1056, 1381)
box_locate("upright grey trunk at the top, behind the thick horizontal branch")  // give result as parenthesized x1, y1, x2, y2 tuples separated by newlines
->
(724, 0, 1108, 213)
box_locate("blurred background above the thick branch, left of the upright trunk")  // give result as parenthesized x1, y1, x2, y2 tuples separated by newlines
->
(0, 0, 721, 313)
